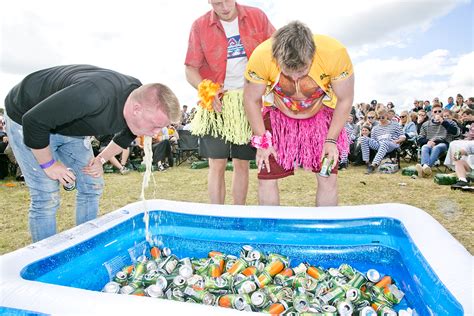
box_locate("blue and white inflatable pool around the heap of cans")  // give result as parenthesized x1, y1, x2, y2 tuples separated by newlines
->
(0, 200, 473, 315)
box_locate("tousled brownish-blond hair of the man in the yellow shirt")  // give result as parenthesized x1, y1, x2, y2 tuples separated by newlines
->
(272, 21, 316, 71)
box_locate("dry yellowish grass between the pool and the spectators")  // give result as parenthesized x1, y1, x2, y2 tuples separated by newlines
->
(0, 163, 474, 254)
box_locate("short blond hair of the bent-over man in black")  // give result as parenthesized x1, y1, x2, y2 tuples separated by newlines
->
(131, 83, 181, 123)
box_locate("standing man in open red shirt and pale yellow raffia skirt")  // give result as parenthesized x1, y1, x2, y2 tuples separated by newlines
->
(185, 0, 275, 204)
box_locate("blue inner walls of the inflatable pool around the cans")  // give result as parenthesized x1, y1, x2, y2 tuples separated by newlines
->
(21, 210, 463, 315)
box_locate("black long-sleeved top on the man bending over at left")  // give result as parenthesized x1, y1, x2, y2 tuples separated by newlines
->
(5, 65, 141, 149)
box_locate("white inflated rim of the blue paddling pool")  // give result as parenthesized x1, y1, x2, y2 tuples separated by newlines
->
(0, 200, 474, 315)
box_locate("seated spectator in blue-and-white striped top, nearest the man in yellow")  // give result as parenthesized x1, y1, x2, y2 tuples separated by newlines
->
(361, 109, 406, 174)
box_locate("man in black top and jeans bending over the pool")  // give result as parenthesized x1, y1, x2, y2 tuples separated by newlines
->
(5, 65, 180, 242)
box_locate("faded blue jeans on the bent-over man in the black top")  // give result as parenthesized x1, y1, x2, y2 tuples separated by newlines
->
(5, 115, 104, 242)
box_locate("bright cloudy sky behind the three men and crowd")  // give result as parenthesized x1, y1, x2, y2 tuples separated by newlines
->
(0, 0, 474, 110)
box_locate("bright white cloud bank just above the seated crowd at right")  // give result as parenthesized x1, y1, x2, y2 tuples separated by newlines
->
(355, 50, 474, 109)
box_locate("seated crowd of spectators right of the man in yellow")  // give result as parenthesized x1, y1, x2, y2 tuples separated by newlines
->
(340, 94, 474, 186)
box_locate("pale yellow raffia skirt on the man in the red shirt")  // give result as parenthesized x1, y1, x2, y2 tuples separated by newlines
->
(191, 90, 252, 145)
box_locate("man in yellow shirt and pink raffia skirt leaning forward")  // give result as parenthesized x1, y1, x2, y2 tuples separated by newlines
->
(244, 21, 354, 206)
